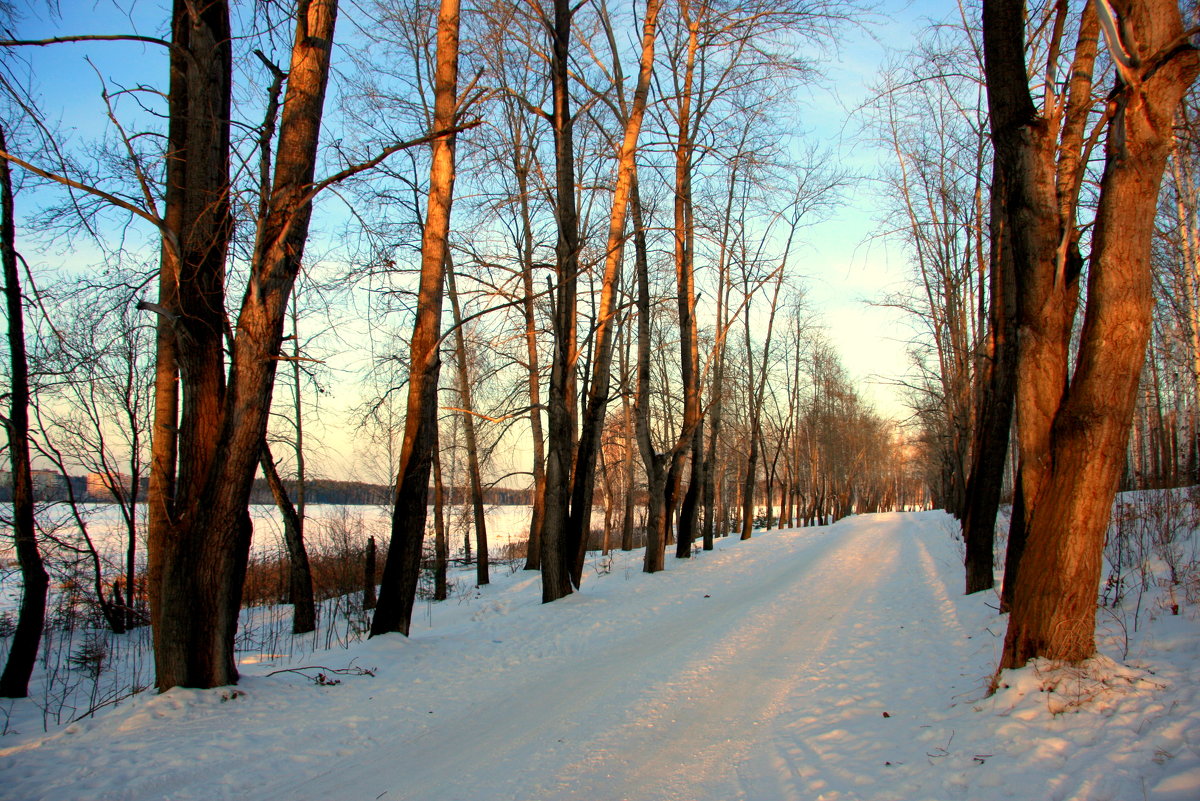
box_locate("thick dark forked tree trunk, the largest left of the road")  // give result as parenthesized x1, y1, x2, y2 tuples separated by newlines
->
(150, 0, 337, 691)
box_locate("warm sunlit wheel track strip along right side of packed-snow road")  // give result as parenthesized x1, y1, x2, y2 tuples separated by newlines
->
(556, 529, 876, 801)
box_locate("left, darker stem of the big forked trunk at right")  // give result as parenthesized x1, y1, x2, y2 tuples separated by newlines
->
(972, 2, 1098, 608)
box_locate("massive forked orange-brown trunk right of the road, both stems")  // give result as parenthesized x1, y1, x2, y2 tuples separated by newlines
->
(984, 0, 1200, 668)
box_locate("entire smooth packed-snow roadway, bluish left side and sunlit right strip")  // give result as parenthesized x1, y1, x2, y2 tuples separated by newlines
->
(263, 526, 897, 801)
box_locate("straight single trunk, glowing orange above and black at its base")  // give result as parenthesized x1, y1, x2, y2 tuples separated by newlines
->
(371, 0, 458, 637)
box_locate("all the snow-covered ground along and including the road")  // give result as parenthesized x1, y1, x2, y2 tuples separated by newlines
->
(0, 512, 1200, 801)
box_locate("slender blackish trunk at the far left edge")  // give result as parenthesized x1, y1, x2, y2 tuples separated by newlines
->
(0, 127, 50, 698)
